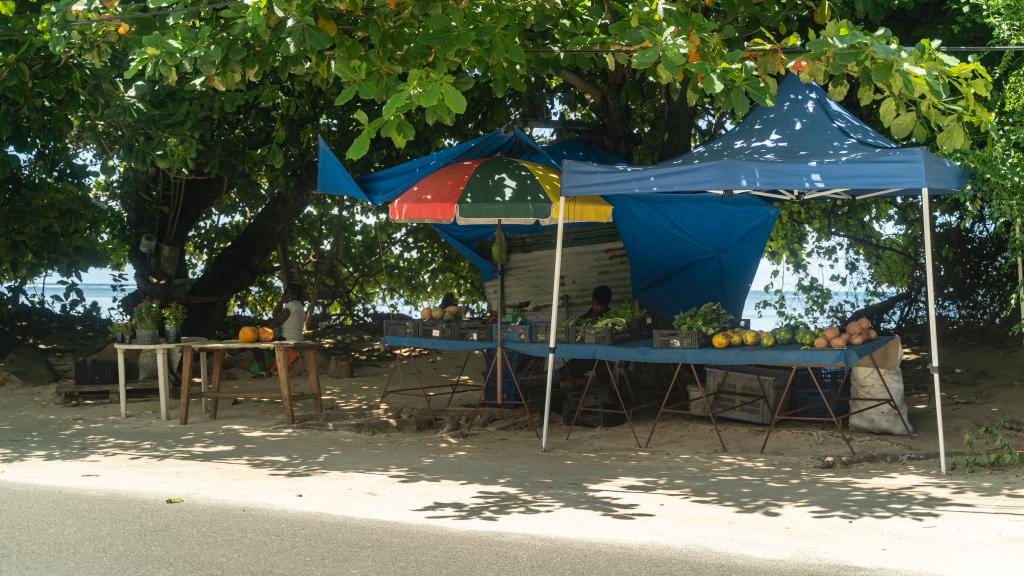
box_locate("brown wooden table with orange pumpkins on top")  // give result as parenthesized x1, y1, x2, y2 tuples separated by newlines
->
(178, 340, 324, 424)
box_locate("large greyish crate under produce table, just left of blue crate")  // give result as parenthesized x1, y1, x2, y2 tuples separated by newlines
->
(701, 366, 790, 424)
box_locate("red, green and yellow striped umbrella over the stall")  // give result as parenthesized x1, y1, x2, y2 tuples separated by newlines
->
(389, 156, 611, 224)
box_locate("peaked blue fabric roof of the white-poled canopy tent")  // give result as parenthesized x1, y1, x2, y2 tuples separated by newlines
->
(562, 74, 968, 197)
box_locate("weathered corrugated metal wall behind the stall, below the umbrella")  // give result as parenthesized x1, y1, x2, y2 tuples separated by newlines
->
(485, 241, 633, 320)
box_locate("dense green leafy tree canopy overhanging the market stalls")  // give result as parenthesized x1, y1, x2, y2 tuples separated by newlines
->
(0, 0, 1024, 334)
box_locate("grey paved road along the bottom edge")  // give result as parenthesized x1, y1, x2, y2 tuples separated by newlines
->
(0, 482, 925, 576)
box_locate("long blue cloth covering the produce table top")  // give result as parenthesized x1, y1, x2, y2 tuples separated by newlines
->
(383, 336, 893, 367)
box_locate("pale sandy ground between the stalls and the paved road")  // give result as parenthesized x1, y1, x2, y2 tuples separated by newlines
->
(0, 342, 1024, 574)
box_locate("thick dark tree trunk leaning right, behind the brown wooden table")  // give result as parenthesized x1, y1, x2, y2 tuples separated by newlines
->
(185, 161, 314, 336)
